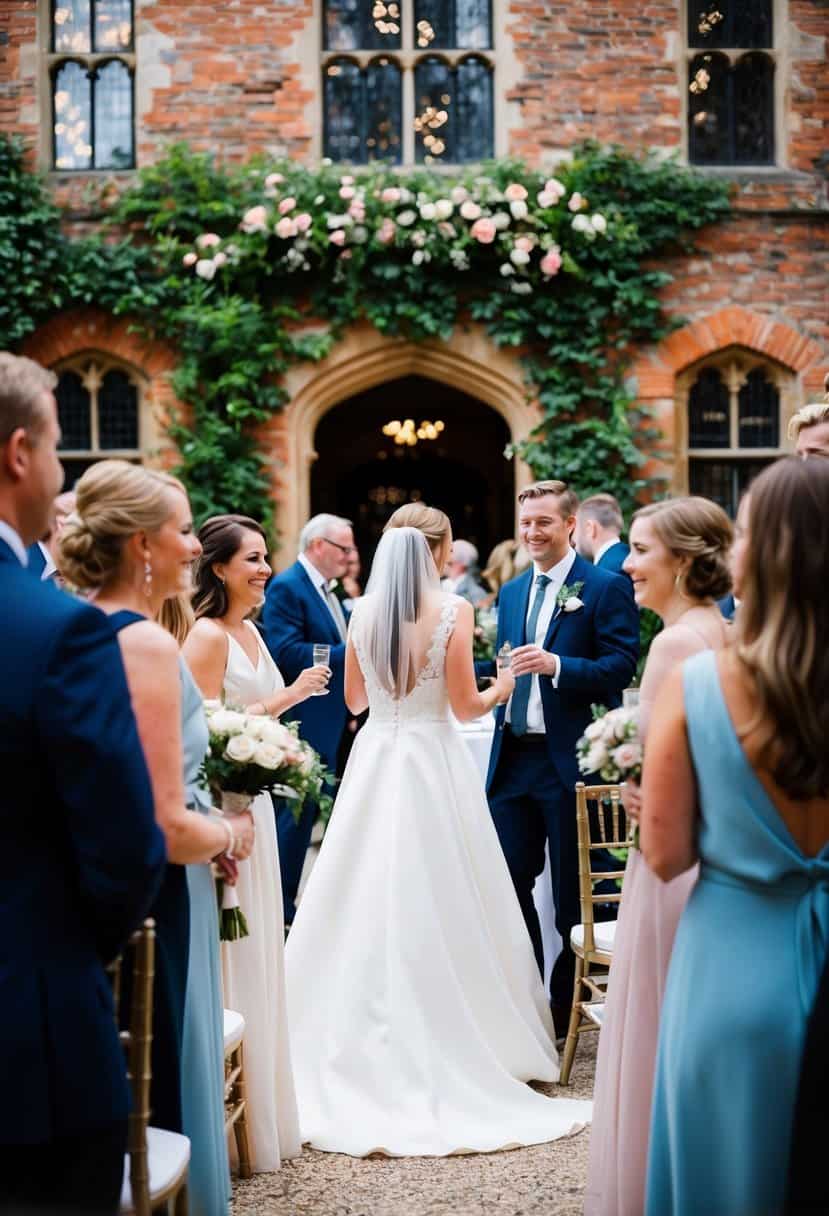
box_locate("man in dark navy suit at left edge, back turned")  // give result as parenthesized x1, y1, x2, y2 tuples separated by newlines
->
(0, 353, 164, 1214)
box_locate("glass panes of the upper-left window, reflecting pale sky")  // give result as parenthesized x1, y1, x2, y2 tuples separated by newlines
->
(49, 0, 135, 170)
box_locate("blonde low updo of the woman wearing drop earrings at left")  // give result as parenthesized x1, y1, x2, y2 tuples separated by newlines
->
(58, 460, 186, 591)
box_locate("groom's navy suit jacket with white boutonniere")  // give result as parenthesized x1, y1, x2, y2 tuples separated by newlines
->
(486, 556, 639, 789)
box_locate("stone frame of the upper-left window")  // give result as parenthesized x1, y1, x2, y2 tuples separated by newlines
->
(38, 0, 139, 178)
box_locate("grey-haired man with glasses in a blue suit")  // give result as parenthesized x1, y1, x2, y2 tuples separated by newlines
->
(263, 514, 356, 925)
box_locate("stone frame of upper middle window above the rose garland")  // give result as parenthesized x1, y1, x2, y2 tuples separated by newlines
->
(311, 0, 510, 171)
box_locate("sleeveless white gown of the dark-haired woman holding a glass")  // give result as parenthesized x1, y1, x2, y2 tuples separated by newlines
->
(221, 621, 301, 1172)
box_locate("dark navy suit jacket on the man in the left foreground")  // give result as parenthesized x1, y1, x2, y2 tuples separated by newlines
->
(0, 541, 164, 1144)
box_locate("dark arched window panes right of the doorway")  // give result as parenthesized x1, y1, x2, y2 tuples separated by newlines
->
(687, 351, 782, 516)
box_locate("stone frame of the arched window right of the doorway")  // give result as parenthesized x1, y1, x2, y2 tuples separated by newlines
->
(672, 344, 801, 494)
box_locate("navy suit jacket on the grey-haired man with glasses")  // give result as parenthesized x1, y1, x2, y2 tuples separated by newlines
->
(263, 562, 349, 770)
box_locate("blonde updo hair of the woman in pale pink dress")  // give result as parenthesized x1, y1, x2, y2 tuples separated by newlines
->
(631, 497, 734, 599)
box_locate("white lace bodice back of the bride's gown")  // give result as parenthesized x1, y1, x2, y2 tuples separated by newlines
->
(351, 595, 459, 725)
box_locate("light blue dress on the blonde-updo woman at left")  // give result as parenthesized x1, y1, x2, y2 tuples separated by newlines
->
(180, 659, 231, 1216)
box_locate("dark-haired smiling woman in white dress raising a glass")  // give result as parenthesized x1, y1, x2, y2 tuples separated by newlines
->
(184, 516, 329, 1172)
